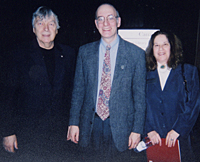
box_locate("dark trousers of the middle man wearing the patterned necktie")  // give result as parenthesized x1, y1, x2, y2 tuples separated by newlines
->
(79, 115, 131, 162)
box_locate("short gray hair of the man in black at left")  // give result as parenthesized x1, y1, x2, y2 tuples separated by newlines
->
(32, 6, 60, 29)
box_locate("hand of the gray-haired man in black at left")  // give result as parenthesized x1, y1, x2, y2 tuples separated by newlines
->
(3, 134, 18, 153)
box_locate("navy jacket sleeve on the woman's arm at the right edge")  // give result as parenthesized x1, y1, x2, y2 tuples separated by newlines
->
(172, 67, 200, 137)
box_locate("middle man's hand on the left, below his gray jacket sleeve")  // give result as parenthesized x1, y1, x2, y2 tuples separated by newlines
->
(67, 125, 79, 144)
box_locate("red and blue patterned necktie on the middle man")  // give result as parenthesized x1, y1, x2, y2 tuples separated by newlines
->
(97, 45, 111, 121)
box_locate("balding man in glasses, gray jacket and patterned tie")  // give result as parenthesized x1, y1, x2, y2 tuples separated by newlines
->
(67, 4, 146, 161)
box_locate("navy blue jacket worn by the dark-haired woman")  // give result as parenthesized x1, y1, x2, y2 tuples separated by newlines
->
(145, 64, 199, 138)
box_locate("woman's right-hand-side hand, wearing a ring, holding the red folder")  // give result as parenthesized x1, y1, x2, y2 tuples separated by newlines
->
(165, 130, 179, 147)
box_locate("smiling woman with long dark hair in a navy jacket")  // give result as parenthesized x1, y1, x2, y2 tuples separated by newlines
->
(145, 31, 199, 162)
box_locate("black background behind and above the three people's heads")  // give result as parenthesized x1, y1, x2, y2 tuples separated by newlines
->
(0, 0, 199, 64)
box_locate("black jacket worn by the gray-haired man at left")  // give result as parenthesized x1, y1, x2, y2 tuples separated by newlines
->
(2, 40, 75, 136)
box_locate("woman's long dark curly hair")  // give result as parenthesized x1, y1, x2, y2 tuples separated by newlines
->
(146, 30, 183, 71)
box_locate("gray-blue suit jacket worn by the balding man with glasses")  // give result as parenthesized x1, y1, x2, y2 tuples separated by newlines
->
(69, 38, 146, 151)
